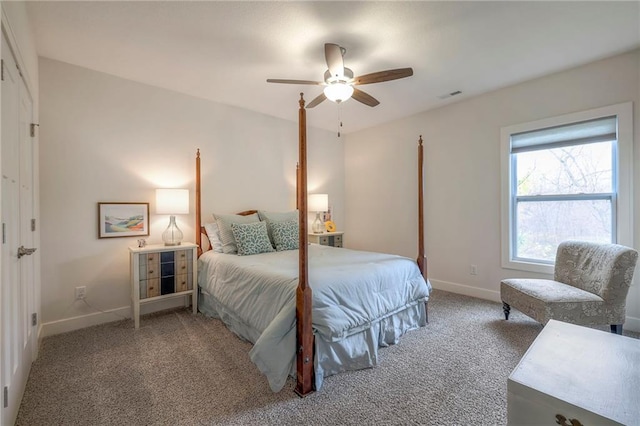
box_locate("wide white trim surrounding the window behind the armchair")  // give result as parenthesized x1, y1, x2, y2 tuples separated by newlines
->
(500, 102, 634, 274)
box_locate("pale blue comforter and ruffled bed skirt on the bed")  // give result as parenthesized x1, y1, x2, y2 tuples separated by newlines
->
(198, 244, 431, 391)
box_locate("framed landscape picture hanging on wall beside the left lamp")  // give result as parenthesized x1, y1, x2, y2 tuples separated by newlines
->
(98, 203, 149, 238)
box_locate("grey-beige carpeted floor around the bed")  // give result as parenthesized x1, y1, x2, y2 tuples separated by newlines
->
(17, 291, 637, 425)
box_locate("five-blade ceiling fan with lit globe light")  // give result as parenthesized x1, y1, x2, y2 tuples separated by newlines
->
(267, 43, 413, 108)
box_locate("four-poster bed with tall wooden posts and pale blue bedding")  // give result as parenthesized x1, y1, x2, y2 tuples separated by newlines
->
(196, 94, 430, 396)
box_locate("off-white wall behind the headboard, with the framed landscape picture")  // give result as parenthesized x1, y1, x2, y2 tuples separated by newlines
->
(40, 58, 344, 334)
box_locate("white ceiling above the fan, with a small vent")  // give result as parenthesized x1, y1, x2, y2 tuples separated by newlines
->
(27, 1, 640, 133)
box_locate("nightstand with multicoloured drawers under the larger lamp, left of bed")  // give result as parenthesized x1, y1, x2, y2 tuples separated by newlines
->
(129, 243, 198, 328)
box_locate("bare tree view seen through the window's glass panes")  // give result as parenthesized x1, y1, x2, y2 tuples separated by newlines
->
(513, 141, 615, 262)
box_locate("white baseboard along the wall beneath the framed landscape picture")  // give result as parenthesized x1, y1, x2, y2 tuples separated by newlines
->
(40, 298, 185, 337)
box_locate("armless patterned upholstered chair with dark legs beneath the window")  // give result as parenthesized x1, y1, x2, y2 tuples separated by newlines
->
(500, 241, 638, 334)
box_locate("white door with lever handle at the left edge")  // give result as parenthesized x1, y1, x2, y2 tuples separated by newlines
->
(0, 28, 37, 425)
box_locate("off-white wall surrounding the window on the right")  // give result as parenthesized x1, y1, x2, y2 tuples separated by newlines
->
(345, 51, 640, 331)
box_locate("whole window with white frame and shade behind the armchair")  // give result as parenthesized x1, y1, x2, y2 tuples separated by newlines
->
(502, 103, 632, 273)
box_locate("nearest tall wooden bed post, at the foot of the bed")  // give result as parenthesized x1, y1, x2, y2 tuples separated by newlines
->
(295, 93, 314, 396)
